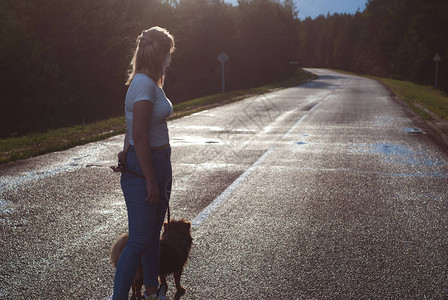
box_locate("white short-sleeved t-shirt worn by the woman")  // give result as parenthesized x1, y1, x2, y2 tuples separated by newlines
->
(125, 73, 173, 147)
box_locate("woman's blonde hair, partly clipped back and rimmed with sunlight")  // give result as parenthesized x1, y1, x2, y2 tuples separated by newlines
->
(126, 26, 174, 87)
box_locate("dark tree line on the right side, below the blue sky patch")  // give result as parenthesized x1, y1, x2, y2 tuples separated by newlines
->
(299, 0, 448, 91)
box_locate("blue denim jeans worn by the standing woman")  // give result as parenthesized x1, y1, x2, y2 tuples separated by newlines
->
(113, 146, 172, 299)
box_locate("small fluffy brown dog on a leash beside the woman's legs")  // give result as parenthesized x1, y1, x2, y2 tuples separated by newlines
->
(110, 219, 193, 299)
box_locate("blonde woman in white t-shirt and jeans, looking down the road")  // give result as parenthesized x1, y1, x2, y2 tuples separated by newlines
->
(113, 27, 174, 299)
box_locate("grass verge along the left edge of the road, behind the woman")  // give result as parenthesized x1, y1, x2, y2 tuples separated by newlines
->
(0, 70, 316, 164)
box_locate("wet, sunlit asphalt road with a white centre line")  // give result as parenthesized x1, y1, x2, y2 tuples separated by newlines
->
(0, 69, 448, 299)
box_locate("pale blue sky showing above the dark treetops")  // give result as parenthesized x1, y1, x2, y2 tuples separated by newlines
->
(226, 0, 367, 20)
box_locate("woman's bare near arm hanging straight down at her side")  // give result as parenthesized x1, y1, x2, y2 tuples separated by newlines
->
(132, 101, 160, 204)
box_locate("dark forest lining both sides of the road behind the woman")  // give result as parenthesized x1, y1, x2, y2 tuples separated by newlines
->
(0, 0, 448, 138)
